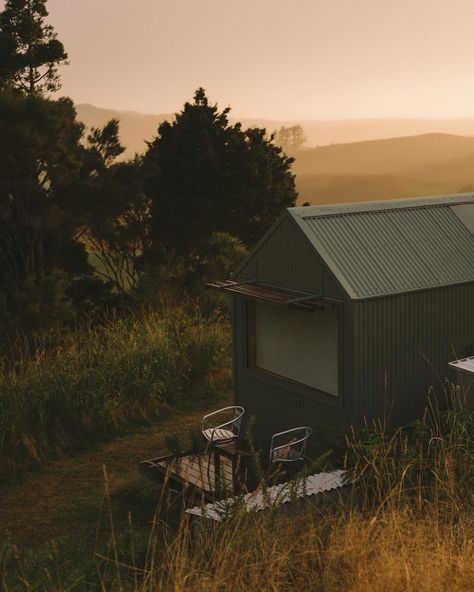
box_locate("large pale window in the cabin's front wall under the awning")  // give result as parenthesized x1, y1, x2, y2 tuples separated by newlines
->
(247, 302, 339, 396)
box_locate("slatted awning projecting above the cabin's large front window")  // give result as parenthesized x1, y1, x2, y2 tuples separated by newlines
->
(206, 280, 324, 310)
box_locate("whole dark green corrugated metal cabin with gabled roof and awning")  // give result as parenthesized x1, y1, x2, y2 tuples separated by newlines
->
(213, 194, 474, 445)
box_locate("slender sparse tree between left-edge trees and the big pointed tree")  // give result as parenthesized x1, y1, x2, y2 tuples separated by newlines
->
(76, 119, 149, 296)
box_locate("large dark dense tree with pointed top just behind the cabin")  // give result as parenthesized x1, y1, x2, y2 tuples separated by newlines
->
(144, 88, 296, 259)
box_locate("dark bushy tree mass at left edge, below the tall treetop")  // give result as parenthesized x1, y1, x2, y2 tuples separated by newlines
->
(0, 91, 149, 333)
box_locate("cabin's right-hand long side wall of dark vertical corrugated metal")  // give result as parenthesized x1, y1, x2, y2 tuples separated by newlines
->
(353, 283, 474, 424)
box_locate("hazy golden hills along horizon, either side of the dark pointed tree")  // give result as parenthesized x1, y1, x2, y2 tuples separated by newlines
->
(77, 105, 474, 203)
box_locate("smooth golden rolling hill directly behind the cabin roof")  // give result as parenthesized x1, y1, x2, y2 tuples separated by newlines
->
(293, 134, 474, 203)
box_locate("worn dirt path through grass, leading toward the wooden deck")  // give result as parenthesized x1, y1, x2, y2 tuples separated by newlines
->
(0, 410, 213, 547)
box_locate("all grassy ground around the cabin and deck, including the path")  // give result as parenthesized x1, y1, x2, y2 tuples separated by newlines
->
(0, 302, 474, 592)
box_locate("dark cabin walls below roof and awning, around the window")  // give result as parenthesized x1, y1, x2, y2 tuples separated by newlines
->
(234, 284, 474, 434)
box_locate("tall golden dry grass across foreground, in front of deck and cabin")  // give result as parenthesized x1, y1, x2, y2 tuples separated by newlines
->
(0, 382, 474, 592)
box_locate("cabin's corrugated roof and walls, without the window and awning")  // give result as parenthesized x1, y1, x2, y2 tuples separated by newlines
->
(234, 195, 474, 434)
